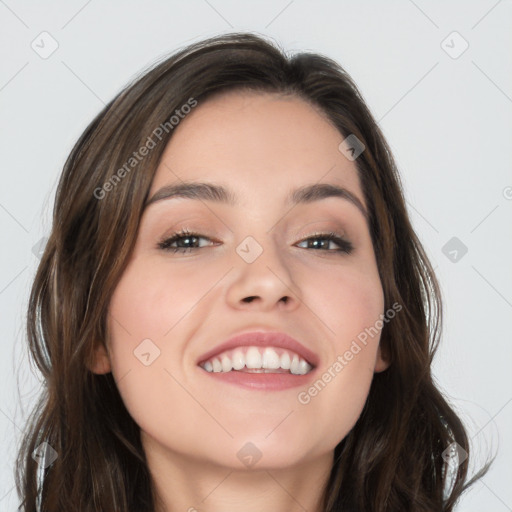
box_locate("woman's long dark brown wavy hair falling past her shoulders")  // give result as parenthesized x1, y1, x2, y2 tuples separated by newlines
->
(16, 33, 488, 512)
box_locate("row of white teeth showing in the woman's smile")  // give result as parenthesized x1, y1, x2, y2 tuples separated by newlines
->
(201, 347, 312, 375)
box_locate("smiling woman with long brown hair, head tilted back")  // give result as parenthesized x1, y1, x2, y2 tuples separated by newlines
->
(17, 34, 490, 512)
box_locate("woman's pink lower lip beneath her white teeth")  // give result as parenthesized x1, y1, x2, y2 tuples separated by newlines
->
(200, 368, 315, 391)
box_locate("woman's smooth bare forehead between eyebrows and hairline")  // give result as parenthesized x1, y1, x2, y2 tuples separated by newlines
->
(150, 91, 364, 204)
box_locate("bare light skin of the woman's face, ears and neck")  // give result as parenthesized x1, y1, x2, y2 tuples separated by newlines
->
(92, 92, 387, 512)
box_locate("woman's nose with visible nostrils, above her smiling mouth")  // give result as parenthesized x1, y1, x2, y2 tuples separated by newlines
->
(227, 239, 302, 311)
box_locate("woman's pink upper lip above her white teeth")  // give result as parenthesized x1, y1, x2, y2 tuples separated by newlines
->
(197, 331, 319, 368)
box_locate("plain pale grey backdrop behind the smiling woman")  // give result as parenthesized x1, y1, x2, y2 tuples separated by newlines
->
(0, 0, 512, 512)
